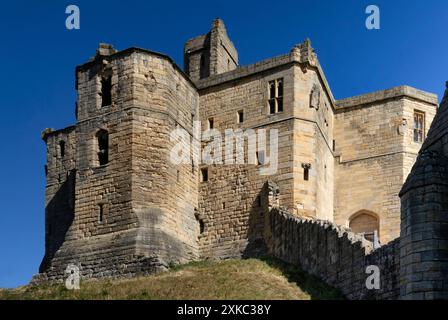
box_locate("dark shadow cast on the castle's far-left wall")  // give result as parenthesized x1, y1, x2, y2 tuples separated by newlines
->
(39, 170, 76, 273)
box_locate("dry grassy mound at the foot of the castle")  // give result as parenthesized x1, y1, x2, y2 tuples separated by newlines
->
(0, 258, 342, 300)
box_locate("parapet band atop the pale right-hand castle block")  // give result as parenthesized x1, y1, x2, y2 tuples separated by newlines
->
(336, 85, 438, 111)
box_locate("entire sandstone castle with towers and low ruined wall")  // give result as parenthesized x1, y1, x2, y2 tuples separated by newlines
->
(35, 19, 448, 299)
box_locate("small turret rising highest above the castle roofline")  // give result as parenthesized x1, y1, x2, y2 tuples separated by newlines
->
(184, 19, 238, 80)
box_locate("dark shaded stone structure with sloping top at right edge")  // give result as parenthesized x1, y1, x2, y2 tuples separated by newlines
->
(400, 82, 448, 300)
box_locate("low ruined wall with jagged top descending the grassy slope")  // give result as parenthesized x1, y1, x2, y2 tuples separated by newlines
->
(265, 208, 400, 300)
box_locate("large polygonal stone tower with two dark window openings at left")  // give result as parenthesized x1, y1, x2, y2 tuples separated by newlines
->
(40, 45, 199, 279)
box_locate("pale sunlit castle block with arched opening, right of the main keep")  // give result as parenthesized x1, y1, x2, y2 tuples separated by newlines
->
(334, 87, 437, 244)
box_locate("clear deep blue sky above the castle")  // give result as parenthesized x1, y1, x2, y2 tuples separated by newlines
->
(0, 0, 448, 287)
